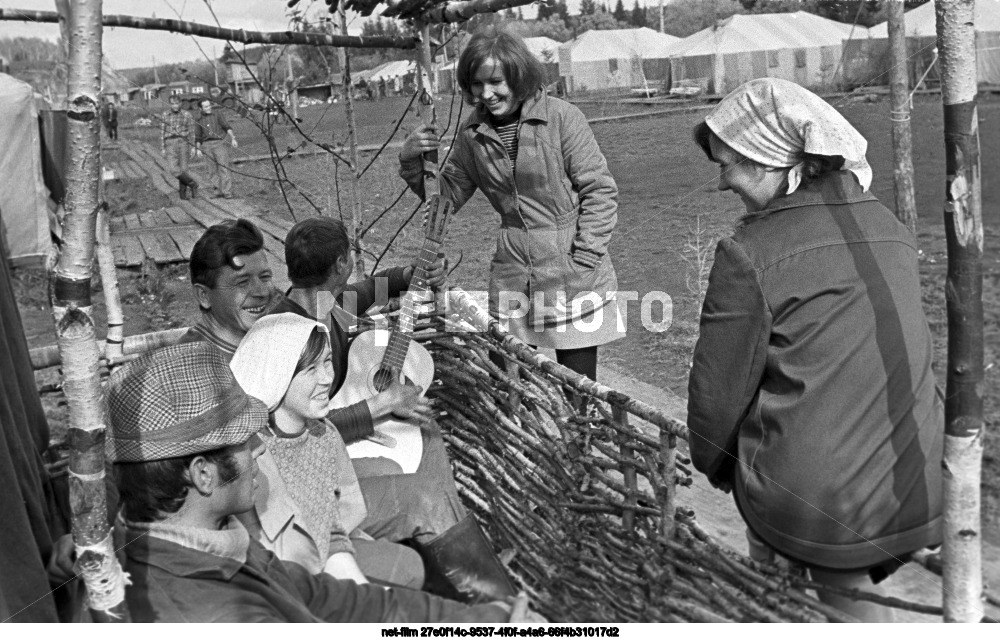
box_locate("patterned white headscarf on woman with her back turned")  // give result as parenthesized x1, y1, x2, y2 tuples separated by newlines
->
(705, 78, 872, 194)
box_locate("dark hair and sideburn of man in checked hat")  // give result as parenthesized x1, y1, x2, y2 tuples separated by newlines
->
(113, 446, 242, 523)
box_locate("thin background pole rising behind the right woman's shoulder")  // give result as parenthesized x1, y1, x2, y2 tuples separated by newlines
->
(887, 0, 917, 238)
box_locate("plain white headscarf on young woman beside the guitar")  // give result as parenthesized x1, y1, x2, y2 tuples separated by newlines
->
(229, 313, 327, 412)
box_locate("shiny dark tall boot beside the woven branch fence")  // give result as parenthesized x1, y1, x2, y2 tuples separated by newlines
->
(416, 514, 517, 603)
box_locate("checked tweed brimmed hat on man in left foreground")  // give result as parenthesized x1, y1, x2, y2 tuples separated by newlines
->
(107, 343, 267, 463)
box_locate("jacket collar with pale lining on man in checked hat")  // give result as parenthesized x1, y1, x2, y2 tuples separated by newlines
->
(125, 517, 250, 581)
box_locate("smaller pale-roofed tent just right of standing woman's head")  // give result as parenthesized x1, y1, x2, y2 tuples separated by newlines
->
(559, 27, 680, 93)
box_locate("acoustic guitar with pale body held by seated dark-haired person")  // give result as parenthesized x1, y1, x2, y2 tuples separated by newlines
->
(330, 195, 451, 474)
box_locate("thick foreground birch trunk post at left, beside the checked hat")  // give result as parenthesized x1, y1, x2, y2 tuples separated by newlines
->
(51, 0, 129, 621)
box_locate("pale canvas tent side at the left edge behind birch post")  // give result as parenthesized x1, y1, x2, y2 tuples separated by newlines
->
(0, 73, 51, 262)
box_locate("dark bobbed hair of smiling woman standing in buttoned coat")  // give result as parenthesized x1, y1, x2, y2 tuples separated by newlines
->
(456, 26, 545, 105)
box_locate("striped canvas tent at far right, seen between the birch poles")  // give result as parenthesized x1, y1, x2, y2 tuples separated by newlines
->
(844, 0, 1000, 86)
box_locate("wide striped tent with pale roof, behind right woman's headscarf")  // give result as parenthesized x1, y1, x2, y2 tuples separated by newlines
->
(669, 11, 867, 94)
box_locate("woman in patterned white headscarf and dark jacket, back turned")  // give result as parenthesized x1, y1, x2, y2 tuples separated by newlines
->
(688, 78, 944, 620)
